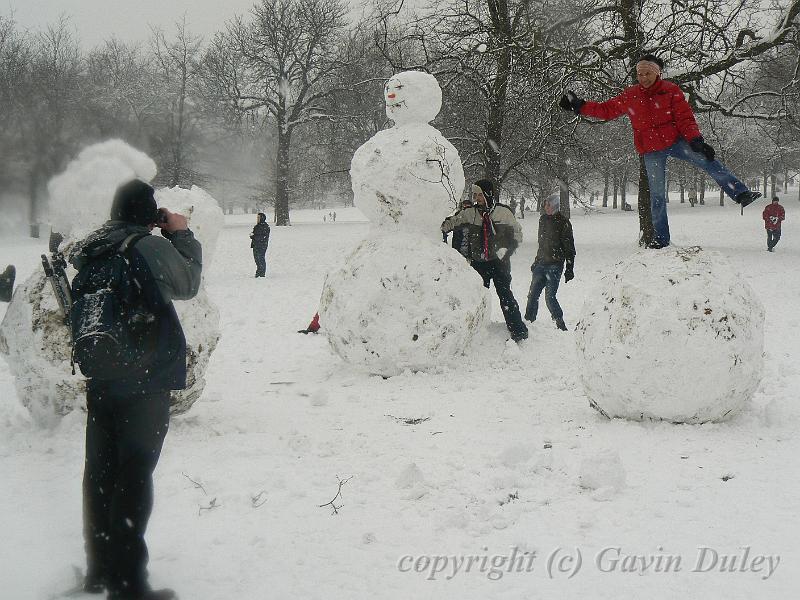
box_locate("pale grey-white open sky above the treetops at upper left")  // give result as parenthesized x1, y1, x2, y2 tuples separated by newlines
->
(0, 0, 294, 49)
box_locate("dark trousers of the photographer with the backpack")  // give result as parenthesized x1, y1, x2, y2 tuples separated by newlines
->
(83, 391, 170, 597)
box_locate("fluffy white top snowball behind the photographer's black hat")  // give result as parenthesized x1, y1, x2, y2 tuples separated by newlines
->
(47, 140, 156, 240)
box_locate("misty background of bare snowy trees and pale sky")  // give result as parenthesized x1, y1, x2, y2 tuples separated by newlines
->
(0, 0, 800, 235)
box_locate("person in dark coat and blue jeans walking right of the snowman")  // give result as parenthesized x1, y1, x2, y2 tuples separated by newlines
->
(525, 194, 575, 331)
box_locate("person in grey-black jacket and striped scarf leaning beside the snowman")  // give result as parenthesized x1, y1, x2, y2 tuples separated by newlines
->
(441, 179, 528, 342)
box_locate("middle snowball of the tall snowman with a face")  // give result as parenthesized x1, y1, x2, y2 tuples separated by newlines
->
(350, 123, 464, 240)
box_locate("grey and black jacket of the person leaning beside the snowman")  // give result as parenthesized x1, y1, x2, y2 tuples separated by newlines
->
(442, 204, 522, 262)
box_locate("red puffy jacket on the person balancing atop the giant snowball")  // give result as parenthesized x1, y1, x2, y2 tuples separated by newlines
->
(581, 79, 700, 154)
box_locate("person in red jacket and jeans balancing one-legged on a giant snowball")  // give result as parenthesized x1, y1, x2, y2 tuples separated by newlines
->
(559, 54, 761, 248)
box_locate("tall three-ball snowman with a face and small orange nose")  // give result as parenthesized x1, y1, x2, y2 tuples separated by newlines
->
(320, 71, 489, 376)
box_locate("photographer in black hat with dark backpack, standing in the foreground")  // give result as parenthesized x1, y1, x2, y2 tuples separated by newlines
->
(70, 179, 202, 600)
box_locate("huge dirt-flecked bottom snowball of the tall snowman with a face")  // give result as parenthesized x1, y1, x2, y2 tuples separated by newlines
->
(320, 233, 489, 376)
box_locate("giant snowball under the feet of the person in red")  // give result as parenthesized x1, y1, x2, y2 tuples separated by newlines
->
(577, 246, 764, 423)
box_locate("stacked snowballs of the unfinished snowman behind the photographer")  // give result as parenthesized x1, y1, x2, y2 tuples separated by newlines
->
(0, 140, 223, 426)
